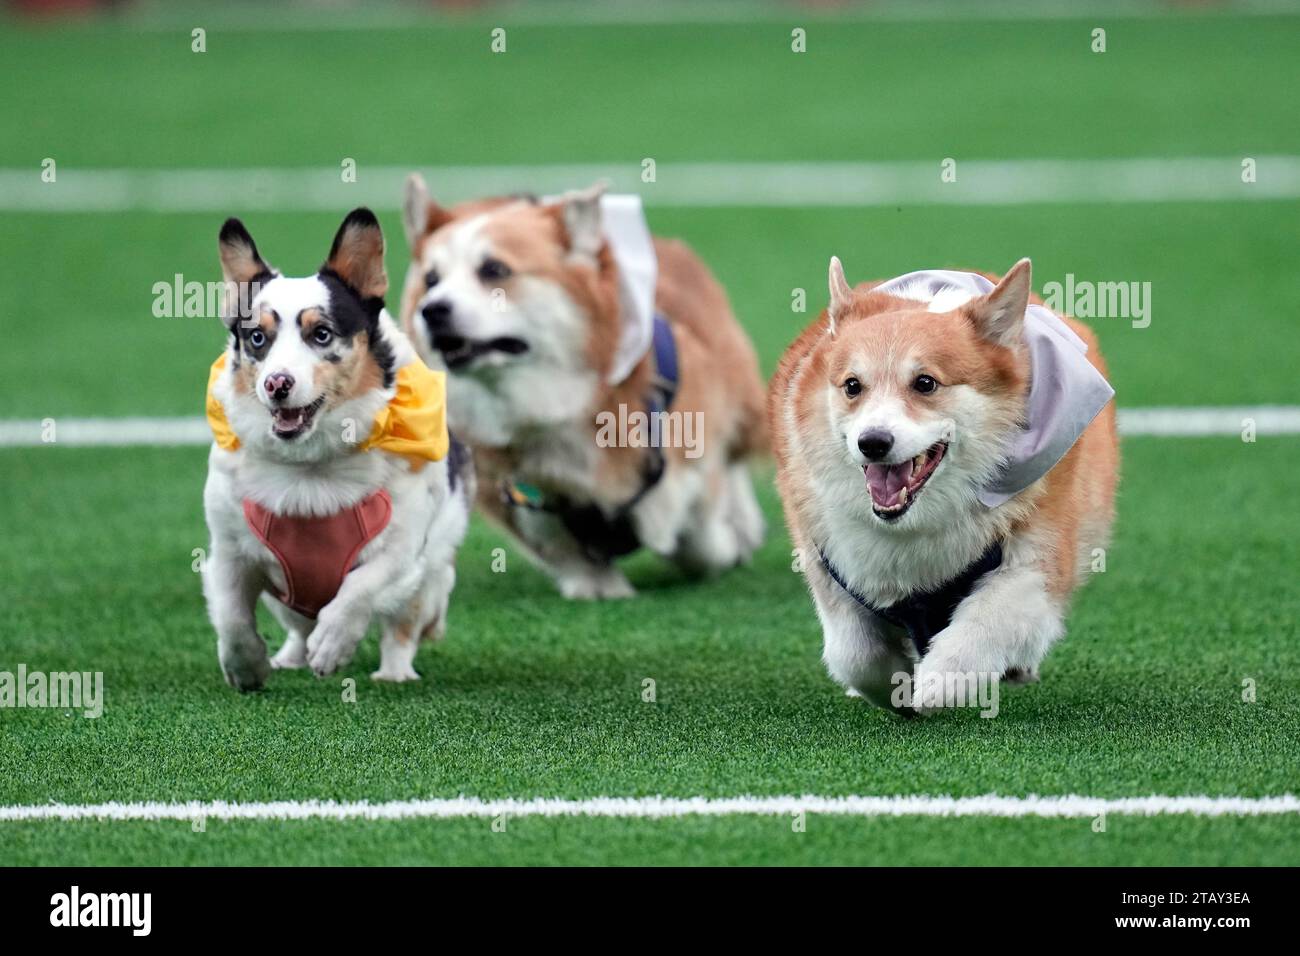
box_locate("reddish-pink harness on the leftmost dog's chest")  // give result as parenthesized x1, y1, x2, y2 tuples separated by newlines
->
(243, 489, 393, 619)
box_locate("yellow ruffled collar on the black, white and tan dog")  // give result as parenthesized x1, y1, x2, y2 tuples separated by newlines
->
(207, 352, 450, 471)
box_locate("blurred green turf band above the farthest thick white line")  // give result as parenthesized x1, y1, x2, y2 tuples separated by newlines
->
(0, 10, 1300, 170)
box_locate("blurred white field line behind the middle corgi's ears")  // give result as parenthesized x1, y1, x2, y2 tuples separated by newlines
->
(0, 155, 1300, 216)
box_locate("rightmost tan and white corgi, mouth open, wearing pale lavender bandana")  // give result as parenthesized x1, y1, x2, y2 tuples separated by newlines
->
(768, 259, 1118, 710)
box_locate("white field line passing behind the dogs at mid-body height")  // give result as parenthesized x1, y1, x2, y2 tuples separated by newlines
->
(0, 405, 1300, 447)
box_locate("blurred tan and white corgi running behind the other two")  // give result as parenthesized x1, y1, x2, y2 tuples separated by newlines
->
(402, 176, 766, 598)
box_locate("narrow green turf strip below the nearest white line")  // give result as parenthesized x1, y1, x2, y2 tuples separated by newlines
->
(5, 816, 1296, 866)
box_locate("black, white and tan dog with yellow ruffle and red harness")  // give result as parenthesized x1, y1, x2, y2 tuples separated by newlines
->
(203, 208, 475, 691)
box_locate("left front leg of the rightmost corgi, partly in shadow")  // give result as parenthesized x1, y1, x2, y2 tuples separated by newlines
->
(807, 564, 913, 710)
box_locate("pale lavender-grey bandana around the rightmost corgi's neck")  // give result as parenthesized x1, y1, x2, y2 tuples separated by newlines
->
(872, 269, 1115, 507)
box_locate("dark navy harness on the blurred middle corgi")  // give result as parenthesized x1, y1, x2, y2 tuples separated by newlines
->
(502, 315, 679, 564)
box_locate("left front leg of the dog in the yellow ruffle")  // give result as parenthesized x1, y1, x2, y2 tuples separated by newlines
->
(203, 544, 270, 691)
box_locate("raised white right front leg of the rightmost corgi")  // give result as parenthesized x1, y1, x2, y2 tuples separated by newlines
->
(913, 566, 1065, 710)
